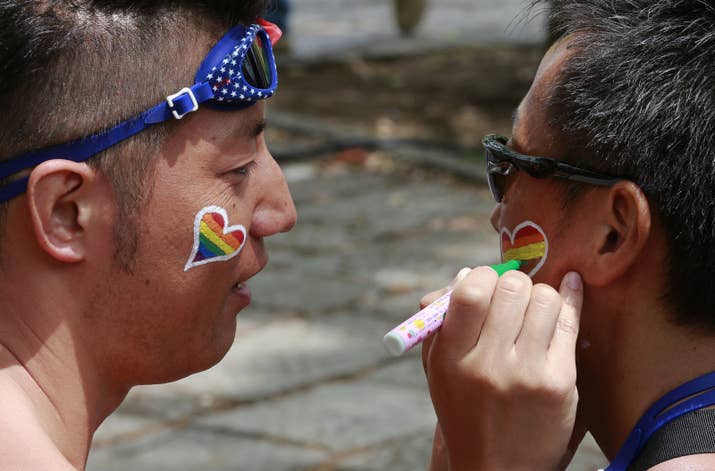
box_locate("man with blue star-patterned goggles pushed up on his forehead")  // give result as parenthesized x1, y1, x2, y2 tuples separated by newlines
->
(0, 4, 296, 470)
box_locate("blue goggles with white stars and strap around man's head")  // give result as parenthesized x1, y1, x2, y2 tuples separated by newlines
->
(0, 19, 281, 202)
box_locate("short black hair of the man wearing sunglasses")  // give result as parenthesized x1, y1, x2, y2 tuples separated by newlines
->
(535, 0, 715, 332)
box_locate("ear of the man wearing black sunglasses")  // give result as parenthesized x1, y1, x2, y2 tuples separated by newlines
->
(584, 181, 652, 286)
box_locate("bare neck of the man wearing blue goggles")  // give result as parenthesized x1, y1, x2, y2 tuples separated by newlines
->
(0, 287, 127, 469)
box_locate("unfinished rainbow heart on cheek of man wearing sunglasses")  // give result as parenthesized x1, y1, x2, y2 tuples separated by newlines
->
(501, 221, 549, 277)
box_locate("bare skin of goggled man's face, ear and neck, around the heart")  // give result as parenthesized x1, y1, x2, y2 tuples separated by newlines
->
(0, 37, 296, 470)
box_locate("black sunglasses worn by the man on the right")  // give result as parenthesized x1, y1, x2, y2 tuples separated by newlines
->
(482, 134, 622, 203)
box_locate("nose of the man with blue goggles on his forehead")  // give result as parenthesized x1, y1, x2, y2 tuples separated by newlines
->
(251, 158, 297, 238)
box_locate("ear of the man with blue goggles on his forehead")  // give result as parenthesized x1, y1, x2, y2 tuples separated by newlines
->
(27, 159, 96, 263)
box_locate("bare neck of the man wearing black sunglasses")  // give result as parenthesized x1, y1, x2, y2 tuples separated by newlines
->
(579, 296, 715, 459)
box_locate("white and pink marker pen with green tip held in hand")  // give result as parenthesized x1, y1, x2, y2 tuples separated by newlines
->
(382, 260, 523, 356)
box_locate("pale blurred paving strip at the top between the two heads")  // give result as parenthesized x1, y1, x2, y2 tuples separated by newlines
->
(292, 0, 544, 59)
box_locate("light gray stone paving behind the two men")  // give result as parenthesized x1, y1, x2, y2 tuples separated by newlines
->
(88, 0, 603, 471)
